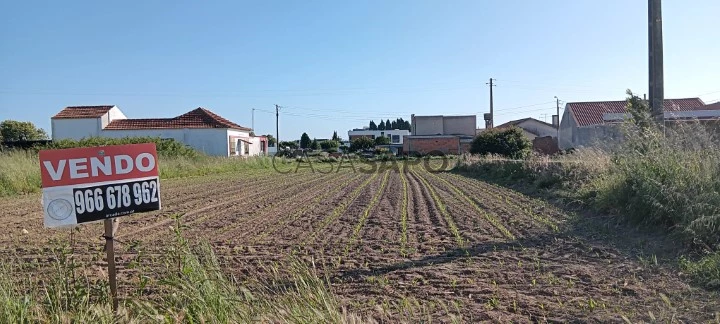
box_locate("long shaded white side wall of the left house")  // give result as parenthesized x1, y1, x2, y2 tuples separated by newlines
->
(101, 128, 230, 156)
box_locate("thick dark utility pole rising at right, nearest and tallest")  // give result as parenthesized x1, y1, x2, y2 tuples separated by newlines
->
(648, 0, 665, 125)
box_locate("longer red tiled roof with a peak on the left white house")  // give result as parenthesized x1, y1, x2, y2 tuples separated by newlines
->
(105, 108, 251, 131)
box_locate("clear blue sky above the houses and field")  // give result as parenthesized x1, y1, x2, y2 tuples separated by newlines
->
(0, 0, 720, 140)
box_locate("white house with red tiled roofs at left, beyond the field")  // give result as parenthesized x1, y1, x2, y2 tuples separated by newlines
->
(51, 106, 268, 156)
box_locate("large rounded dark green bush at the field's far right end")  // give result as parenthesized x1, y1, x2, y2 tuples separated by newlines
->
(470, 127, 532, 159)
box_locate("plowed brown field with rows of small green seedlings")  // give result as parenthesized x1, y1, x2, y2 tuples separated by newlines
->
(0, 166, 720, 322)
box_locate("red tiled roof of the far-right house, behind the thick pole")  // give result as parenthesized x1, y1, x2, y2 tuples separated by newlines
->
(567, 98, 705, 127)
